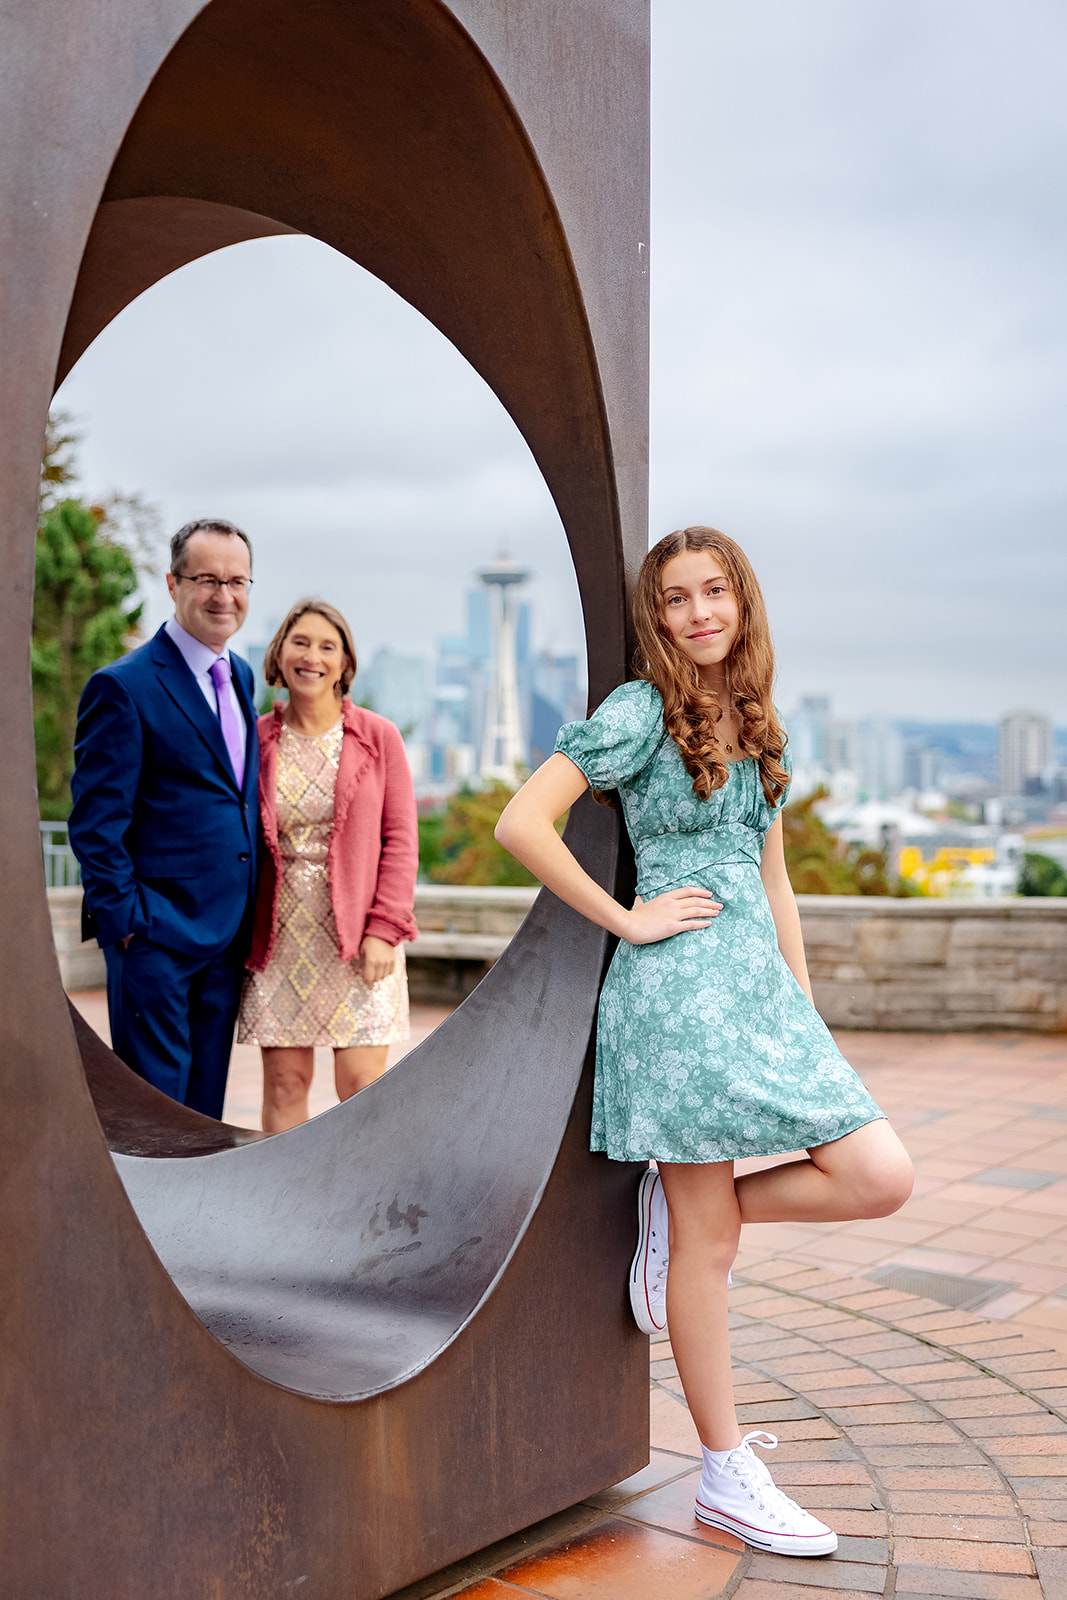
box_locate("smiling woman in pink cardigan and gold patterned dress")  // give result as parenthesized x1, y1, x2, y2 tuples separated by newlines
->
(237, 600, 419, 1133)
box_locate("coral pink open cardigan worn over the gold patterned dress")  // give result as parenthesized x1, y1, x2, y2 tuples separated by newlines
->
(246, 699, 419, 973)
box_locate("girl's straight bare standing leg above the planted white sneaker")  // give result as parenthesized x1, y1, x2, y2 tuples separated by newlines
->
(659, 1162, 741, 1450)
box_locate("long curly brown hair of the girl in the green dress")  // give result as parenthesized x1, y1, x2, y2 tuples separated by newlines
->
(633, 528, 789, 805)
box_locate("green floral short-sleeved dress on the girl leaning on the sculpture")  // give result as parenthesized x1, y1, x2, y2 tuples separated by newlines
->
(555, 683, 883, 1162)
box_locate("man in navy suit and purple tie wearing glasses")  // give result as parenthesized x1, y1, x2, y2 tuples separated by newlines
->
(69, 520, 259, 1117)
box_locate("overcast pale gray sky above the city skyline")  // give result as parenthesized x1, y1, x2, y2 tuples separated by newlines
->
(59, 0, 1067, 722)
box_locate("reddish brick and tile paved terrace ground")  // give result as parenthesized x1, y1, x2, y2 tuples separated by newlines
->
(64, 997, 1067, 1600)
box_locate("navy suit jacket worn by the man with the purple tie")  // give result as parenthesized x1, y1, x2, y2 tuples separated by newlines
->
(69, 629, 259, 958)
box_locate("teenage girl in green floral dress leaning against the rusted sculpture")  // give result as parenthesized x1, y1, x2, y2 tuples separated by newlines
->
(496, 528, 912, 1555)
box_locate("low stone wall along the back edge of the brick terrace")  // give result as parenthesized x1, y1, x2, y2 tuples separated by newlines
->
(48, 883, 1067, 1034)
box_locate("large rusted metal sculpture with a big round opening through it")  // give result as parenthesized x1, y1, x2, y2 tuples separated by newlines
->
(0, 0, 648, 1600)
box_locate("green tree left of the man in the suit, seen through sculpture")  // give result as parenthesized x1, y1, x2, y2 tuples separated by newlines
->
(30, 413, 158, 821)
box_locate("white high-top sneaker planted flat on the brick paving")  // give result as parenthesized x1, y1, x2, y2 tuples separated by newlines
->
(696, 1430, 837, 1555)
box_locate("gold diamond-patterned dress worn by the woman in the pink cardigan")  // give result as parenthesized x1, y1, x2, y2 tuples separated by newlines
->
(237, 720, 408, 1050)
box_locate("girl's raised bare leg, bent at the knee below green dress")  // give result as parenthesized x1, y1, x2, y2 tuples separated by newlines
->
(735, 1118, 913, 1222)
